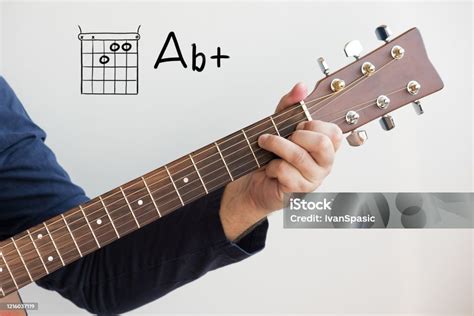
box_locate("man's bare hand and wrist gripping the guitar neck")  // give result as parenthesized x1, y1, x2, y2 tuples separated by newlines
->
(220, 84, 342, 240)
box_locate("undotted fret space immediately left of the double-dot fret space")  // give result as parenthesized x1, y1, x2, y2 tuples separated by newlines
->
(12, 232, 47, 280)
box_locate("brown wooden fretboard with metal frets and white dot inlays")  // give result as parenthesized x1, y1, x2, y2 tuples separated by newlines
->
(0, 104, 310, 296)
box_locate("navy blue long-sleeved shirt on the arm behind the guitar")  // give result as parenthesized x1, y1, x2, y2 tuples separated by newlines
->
(0, 77, 268, 314)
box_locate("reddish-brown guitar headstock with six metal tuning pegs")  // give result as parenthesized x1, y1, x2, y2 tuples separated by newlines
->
(304, 26, 444, 146)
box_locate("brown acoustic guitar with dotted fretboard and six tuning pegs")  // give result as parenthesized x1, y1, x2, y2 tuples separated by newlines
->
(0, 26, 443, 312)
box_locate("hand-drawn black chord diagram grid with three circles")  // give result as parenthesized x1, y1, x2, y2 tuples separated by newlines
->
(78, 27, 140, 95)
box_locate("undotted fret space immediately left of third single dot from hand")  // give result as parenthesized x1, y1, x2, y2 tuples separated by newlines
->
(64, 207, 100, 256)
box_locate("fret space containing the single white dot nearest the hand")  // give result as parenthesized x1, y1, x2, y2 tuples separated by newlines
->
(167, 156, 206, 204)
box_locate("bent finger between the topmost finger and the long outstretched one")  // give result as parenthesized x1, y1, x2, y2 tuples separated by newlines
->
(288, 130, 335, 169)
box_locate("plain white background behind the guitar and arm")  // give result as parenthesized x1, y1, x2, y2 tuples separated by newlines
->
(0, 1, 474, 315)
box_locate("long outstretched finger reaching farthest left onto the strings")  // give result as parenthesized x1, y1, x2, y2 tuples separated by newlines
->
(258, 134, 321, 181)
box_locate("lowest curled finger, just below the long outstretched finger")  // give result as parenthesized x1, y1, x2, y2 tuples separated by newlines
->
(265, 159, 315, 193)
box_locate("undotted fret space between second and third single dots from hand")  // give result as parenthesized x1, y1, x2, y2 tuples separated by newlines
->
(102, 188, 138, 236)
